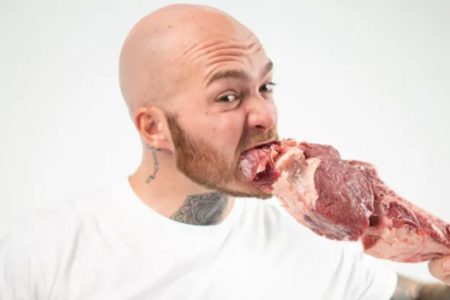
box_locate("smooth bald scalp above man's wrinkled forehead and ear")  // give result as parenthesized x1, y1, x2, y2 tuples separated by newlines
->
(120, 4, 256, 115)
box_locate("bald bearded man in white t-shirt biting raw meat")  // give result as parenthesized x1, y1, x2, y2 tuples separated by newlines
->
(0, 5, 450, 300)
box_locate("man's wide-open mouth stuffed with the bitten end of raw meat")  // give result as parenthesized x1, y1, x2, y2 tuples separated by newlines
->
(239, 141, 280, 193)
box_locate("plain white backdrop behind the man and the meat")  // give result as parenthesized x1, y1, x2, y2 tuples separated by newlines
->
(0, 0, 450, 280)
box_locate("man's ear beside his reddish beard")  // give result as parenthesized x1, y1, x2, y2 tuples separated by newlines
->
(134, 106, 173, 151)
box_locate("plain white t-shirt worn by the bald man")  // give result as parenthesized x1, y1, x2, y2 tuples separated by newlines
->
(0, 178, 397, 300)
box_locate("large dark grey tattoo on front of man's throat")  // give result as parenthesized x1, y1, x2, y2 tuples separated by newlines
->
(170, 192, 228, 225)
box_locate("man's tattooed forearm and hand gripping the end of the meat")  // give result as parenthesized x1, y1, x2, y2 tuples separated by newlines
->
(391, 257, 450, 300)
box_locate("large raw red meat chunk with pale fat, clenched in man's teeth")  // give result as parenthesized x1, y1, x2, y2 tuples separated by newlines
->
(241, 140, 450, 262)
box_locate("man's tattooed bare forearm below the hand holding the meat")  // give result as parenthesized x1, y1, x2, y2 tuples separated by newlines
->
(391, 275, 450, 300)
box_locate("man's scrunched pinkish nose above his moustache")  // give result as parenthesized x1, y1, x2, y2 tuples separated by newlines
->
(247, 97, 277, 131)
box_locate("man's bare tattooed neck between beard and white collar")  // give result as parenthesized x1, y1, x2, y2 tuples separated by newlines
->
(129, 151, 234, 225)
